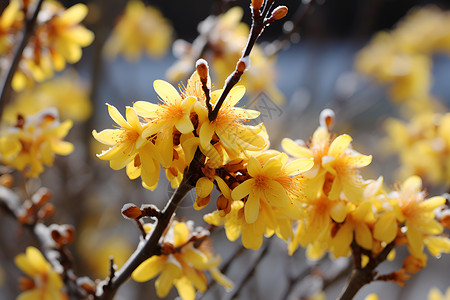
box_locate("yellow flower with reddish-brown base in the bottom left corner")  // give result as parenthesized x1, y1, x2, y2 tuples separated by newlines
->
(14, 247, 69, 300)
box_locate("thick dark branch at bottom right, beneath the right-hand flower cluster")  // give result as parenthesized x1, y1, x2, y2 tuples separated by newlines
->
(338, 241, 395, 300)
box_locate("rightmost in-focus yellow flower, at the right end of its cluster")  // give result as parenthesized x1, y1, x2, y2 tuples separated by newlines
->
(388, 176, 445, 256)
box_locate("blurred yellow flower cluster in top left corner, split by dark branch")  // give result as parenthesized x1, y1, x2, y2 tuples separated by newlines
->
(0, 0, 94, 90)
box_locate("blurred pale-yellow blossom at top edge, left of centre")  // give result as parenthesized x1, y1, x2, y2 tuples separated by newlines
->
(104, 0, 172, 61)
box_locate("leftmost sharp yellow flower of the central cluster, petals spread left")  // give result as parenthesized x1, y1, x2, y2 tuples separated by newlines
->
(92, 104, 164, 190)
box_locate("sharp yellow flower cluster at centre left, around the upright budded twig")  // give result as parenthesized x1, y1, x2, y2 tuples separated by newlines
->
(93, 62, 268, 190)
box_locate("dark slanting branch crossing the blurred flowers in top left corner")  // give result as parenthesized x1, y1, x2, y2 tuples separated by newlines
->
(0, 0, 44, 120)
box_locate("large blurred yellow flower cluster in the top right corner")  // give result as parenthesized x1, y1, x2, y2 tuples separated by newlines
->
(356, 7, 450, 112)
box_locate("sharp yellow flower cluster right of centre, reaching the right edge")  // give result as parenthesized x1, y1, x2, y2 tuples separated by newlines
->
(282, 111, 450, 284)
